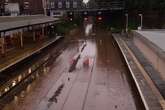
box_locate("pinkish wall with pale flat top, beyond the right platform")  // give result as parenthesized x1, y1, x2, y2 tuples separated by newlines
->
(133, 30, 165, 80)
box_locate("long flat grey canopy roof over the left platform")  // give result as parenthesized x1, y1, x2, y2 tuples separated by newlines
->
(0, 15, 59, 32)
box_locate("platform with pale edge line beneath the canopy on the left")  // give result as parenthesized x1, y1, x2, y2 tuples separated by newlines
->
(0, 36, 62, 72)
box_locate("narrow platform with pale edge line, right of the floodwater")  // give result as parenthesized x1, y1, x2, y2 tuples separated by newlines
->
(113, 34, 164, 110)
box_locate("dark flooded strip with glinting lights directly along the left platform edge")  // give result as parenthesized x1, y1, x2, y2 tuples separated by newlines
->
(0, 41, 66, 109)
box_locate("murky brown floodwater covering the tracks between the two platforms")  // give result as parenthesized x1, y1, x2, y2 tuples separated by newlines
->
(4, 28, 144, 110)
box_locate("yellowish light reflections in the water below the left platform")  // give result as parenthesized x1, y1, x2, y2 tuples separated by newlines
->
(0, 48, 58, 110)
